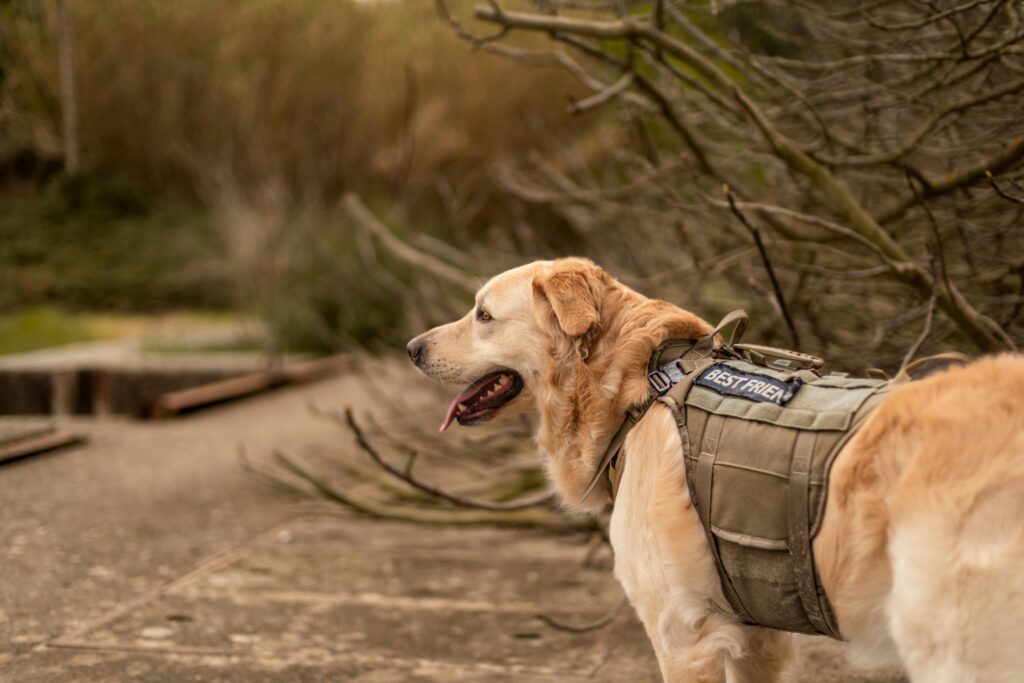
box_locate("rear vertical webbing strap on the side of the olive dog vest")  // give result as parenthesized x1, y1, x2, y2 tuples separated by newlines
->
(788, 431, 839, 638)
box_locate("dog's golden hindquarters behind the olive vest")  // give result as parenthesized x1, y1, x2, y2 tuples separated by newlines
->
(821, 355, 1024, 683)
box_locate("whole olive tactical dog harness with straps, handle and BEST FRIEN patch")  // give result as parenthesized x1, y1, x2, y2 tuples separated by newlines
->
(584, 311, 964, 639)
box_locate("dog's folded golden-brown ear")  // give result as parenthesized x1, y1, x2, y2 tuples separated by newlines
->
(534, 259, 601, 339)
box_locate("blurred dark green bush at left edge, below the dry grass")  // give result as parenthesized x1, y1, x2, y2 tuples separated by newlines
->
(0, 170, 230, 310)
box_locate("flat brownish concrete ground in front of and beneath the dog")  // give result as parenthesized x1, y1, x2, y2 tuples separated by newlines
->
(0, 370, 913, 683)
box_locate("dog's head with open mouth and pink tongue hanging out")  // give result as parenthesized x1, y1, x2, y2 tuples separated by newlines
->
(408, 258, 614, 431)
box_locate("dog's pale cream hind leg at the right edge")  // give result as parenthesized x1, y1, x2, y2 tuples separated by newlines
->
(888, 482, 1024, 683)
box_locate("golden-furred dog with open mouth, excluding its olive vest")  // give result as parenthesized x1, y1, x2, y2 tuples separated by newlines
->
(408, 258, 1024, 683)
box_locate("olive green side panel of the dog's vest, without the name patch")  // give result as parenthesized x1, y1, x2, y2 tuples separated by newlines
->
(651, 360, 890, 638)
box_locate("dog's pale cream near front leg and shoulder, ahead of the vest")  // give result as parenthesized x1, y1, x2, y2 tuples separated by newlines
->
(609, 405, 771, 683)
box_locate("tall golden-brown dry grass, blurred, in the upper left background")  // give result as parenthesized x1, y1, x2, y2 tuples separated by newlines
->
(0, 0, 589, 211)
